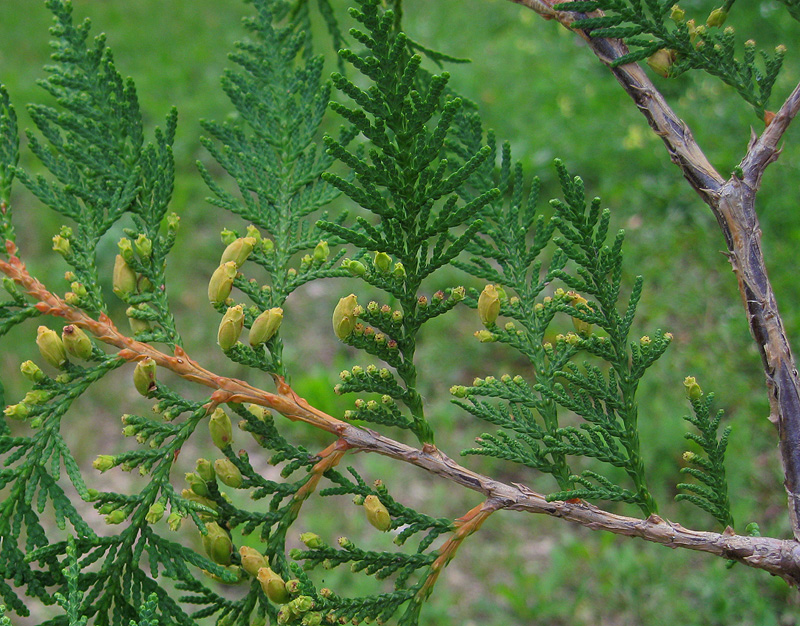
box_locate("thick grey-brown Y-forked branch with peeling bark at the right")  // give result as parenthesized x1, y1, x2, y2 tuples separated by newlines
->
(512, 0, 800, 540)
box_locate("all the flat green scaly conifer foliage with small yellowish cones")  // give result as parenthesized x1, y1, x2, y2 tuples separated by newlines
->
(0, 0, 792, 626)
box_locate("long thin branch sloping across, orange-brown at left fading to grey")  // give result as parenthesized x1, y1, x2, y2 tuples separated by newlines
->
(0, 242, 800, 586)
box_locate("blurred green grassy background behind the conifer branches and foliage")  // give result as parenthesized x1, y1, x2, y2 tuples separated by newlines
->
(0, 0, 800, 626)
